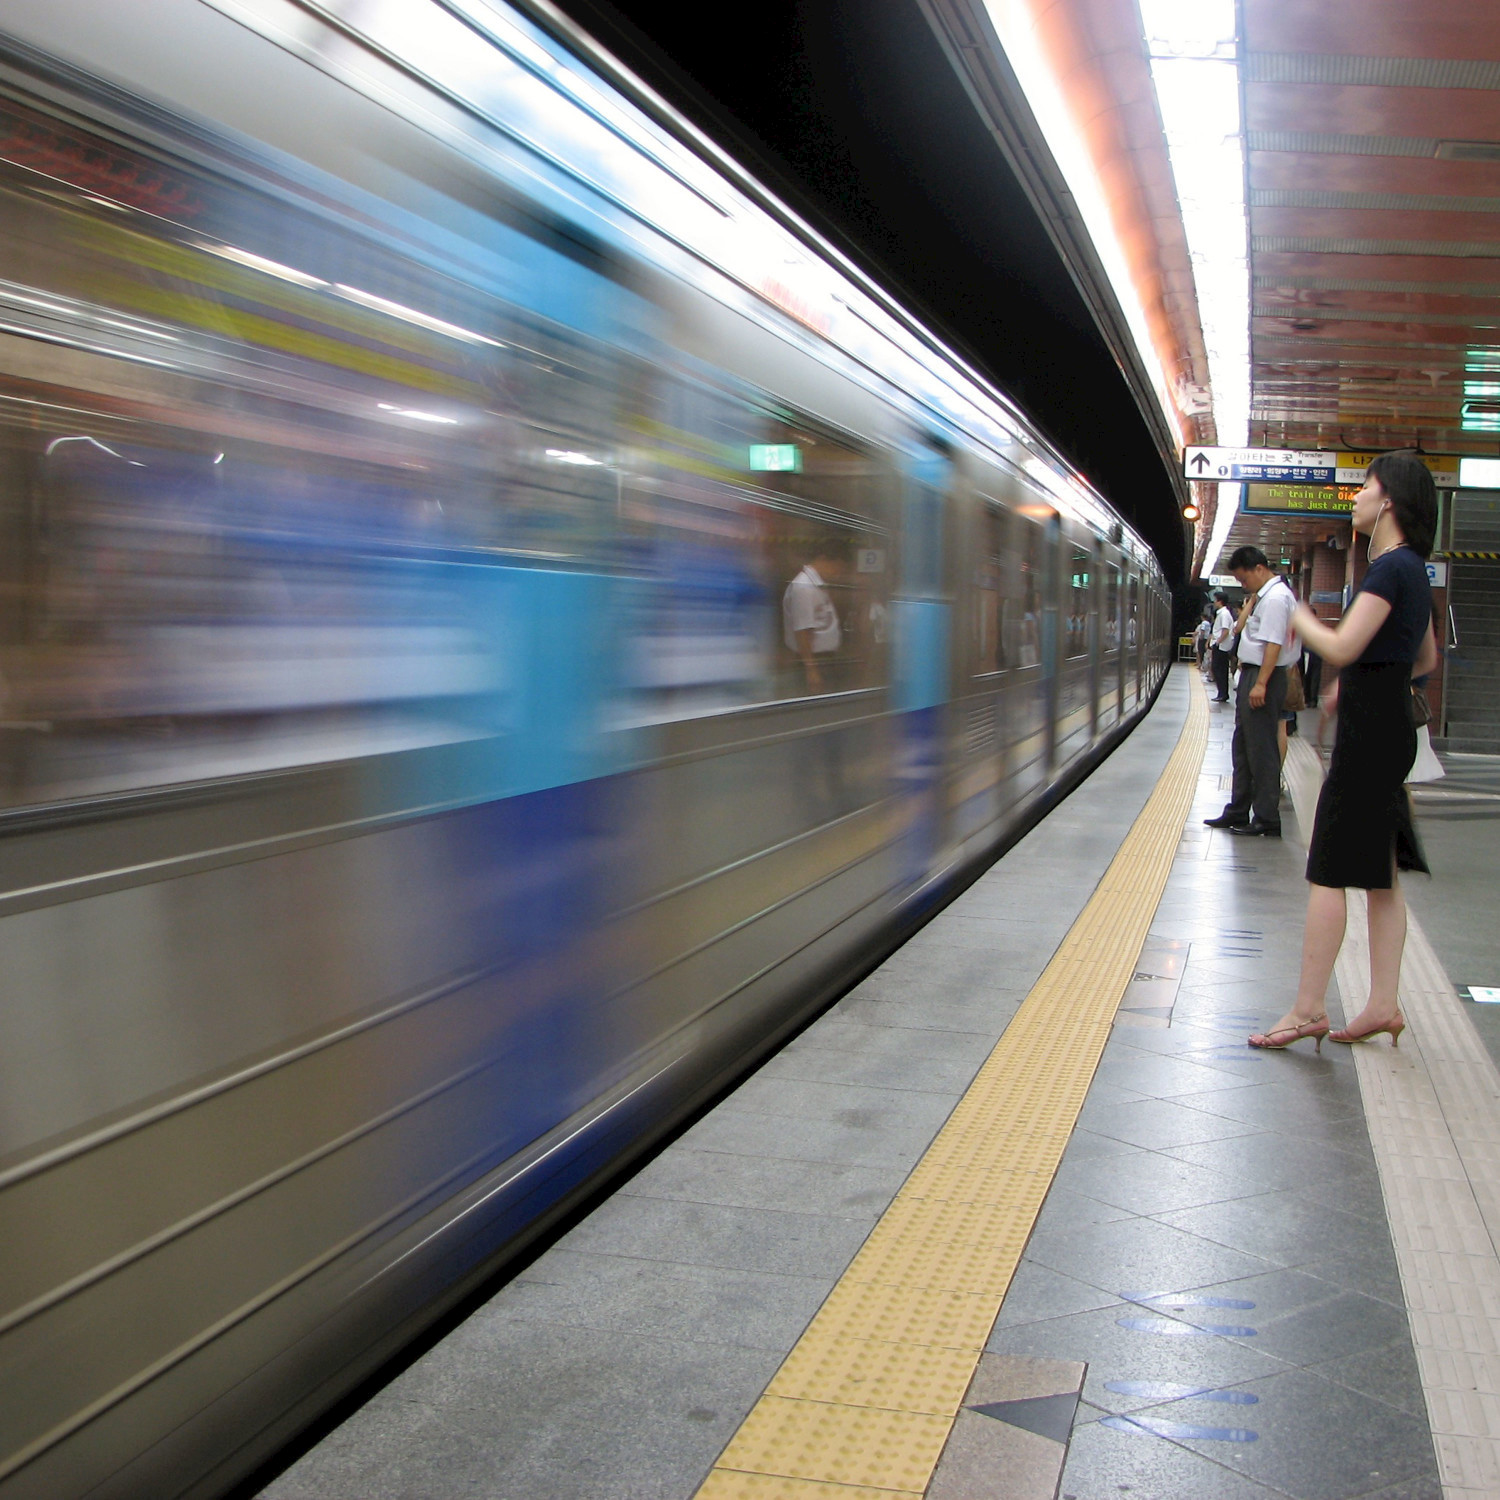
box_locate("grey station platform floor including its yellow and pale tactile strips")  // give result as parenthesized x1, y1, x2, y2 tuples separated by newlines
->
(263, 668, 1500, 1500)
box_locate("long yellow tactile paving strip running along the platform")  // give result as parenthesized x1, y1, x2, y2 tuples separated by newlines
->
(698, 692, 1209, 1500)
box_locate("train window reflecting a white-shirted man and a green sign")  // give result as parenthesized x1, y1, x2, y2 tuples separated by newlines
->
(621, 371, 890, 722)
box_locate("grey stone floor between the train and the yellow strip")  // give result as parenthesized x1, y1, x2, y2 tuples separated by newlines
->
(263, 684, 1194, 1500)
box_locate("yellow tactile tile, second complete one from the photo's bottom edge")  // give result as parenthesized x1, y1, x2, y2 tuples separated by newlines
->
(767, 1329, 980, 1418)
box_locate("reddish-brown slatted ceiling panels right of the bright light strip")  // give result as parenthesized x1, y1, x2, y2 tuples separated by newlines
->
(1242, 0, 1500, 453)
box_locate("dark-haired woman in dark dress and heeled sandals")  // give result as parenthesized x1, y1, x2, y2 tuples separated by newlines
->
(1250, 453, 1437, 1049)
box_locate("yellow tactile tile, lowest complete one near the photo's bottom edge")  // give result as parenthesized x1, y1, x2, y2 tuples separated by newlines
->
(716, 1395, 953, 1491)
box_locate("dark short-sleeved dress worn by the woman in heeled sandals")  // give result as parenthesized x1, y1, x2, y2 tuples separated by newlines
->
(1307, 546, 1433, 891)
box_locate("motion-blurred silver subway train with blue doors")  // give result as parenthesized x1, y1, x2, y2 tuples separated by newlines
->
(0, 0, 1169, 1500)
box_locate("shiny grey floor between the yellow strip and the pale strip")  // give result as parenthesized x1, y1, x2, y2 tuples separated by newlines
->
(989, 687, 1442, 1500)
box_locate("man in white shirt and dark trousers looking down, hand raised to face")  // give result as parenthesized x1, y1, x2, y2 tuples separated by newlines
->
(1203, 546, 1301, 839)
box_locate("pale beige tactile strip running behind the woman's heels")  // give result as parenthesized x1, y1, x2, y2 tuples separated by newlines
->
(1287, 740, 1500, 1500)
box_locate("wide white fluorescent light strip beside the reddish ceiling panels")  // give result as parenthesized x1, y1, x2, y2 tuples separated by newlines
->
(1140, 0, 1250, 573)
